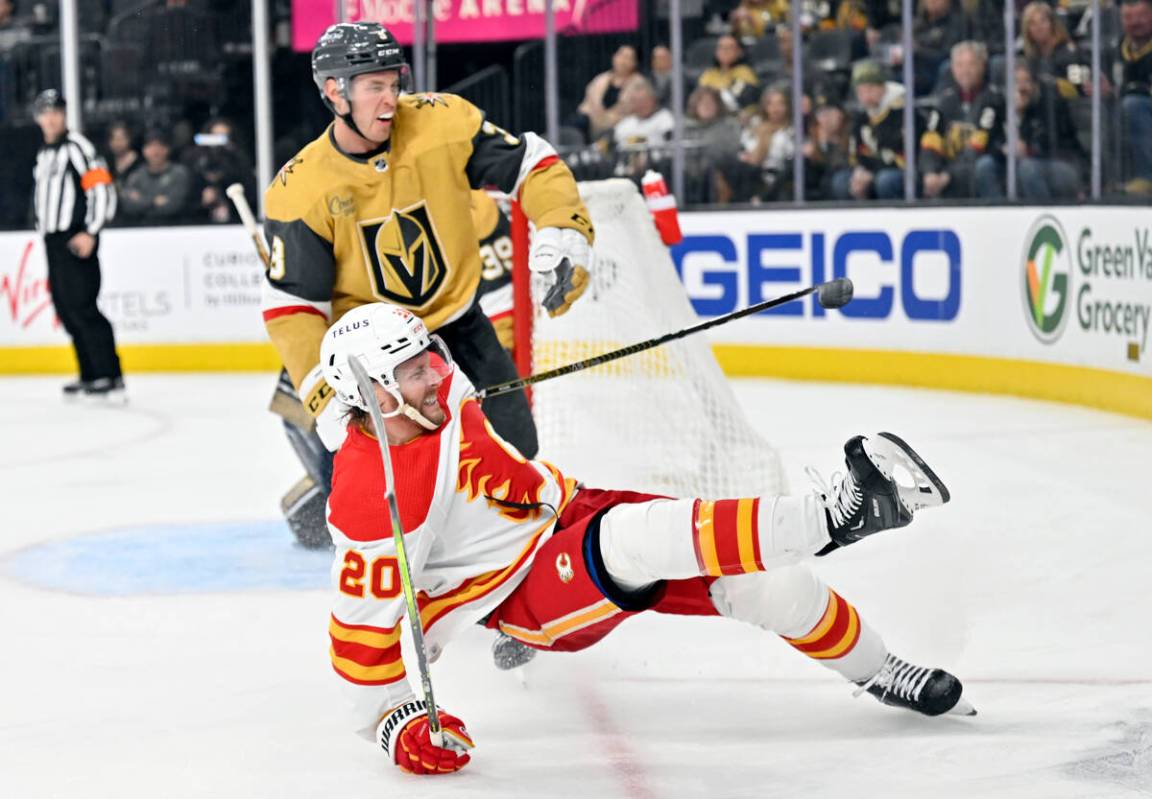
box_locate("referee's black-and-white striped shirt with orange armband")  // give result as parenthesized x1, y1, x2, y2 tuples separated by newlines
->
(35, 131, 116, 236)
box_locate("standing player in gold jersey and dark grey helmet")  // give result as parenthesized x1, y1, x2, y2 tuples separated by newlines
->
(264, 23, 592, 467)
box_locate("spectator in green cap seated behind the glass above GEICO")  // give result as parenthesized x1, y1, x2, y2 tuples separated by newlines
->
(832, 61, 905, 200)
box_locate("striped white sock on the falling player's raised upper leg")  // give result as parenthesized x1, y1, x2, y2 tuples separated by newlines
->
(600, 494, 829, 589)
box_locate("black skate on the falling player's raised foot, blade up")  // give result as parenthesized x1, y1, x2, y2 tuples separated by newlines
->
(809, 433, 949, 555)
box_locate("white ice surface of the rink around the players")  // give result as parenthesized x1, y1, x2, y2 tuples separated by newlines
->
(0, 375, 1152, 799)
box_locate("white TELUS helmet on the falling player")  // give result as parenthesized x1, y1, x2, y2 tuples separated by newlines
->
(320, 303, 452, 419)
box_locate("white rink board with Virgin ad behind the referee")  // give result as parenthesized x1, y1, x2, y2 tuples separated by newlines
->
(0, 226, 265, 347)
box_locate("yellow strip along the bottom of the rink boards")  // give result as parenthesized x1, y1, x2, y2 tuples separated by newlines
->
(0, 343, 1152, 419)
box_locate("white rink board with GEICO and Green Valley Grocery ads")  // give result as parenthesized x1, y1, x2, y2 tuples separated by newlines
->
(672, 207, 1152, 373)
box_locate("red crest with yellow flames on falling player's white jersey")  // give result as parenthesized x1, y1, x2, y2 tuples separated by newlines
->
(456, 400, 547, 522)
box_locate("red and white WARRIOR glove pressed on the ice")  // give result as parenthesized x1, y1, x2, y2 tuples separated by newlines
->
(376, 700, 475, 774)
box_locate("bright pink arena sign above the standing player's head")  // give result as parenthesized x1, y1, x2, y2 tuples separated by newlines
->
(291, 0, 638, 52)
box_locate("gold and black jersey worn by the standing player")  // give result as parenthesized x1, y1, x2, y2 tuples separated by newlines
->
(264, 94, 593, 388)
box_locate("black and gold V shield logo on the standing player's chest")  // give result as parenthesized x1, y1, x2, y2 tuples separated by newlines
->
(359, 203, 448, 307)
